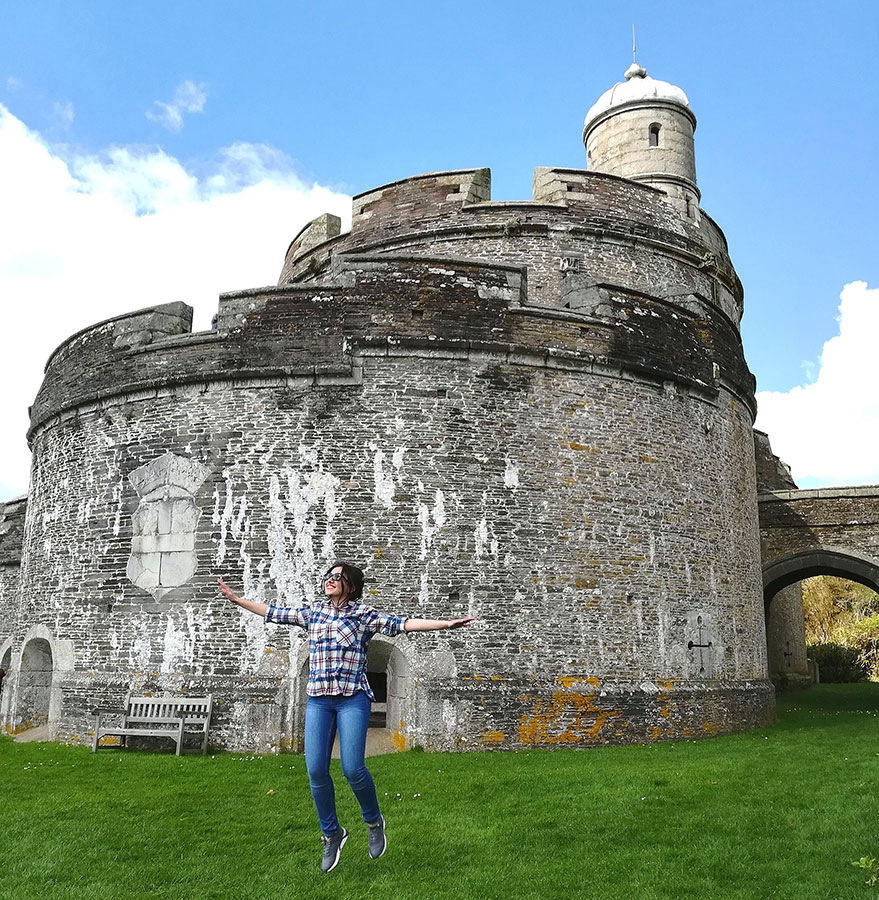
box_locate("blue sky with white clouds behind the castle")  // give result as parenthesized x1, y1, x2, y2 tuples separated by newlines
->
(0, 0, 879, 500)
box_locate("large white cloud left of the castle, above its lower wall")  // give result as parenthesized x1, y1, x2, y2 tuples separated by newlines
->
(0, 104, 351, 500)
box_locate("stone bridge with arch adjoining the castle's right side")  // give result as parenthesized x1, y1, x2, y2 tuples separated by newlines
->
(759, 485, 879, 687)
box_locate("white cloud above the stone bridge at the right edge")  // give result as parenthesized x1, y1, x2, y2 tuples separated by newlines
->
(757, 281, 879, 487)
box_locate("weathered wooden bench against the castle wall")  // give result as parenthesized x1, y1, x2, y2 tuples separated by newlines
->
(92, 694, 213, 756)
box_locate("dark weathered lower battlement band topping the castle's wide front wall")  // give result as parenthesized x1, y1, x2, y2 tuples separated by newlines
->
(29, 254, 754, 440)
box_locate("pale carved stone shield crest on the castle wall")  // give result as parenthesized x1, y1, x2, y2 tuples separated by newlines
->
(126, 453, 208, 600)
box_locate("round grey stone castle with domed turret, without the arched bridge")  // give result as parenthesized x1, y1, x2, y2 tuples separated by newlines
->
(0, 64, 788, 751)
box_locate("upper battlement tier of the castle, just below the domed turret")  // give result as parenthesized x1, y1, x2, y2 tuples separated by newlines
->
(278, 167, 743, 325)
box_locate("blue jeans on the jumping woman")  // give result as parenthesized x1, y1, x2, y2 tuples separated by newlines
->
(305, 691, 381, 834)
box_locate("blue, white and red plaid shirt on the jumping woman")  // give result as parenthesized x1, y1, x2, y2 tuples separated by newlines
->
(266, 600, 406, 700)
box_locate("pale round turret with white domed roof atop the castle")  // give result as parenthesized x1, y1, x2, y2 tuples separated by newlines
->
(583, 62, 699, 219)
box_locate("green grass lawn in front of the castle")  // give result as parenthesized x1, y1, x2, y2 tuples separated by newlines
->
(0, 684, 879, 900)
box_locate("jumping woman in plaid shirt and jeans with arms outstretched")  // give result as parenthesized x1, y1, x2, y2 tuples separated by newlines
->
(218, 562, 473, 872)
